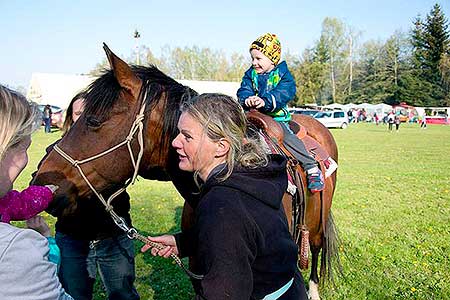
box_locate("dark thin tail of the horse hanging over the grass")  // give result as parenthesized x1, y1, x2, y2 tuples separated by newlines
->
(320, 210, 343, 285)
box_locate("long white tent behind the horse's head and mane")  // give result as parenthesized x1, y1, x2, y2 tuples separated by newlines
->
(27, 73, 240, 109)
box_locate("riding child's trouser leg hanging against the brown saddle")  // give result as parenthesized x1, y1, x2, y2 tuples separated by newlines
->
(280, 122, 317, 171)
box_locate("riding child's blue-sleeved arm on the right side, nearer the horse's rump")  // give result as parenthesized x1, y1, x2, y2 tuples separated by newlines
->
(259, 67, 297, 112)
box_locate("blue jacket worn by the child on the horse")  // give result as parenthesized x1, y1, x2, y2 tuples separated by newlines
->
(237, 61, 296, 121)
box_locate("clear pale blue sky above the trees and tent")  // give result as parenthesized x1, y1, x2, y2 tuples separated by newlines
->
(0, 0, 450, 89)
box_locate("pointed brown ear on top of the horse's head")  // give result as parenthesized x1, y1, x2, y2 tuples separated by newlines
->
(103, 43, 142, 99)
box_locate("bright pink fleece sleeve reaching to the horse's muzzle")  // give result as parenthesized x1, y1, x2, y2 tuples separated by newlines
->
(0, 185, 53, 223)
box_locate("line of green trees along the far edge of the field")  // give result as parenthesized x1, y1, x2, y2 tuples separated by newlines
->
(91, 4, 450, 106)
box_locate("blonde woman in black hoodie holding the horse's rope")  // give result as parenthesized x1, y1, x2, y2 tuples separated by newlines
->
(141, 94, 307, 300)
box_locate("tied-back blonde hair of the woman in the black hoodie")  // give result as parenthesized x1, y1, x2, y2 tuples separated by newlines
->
(181, 93, 268, 181)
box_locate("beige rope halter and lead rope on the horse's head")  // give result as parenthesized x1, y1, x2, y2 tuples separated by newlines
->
(53, 97, 204, 280)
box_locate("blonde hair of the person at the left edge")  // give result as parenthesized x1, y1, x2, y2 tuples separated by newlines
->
(0, 85, 41, 161)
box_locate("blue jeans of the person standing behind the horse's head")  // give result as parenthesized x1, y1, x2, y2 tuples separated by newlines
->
(56, 232, 139, 300)
